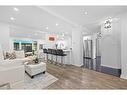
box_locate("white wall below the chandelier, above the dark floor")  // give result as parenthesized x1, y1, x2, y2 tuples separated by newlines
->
(101, 21, 121, 69)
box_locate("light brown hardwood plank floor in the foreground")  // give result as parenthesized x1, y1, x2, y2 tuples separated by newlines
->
(45, 63, 127, 89)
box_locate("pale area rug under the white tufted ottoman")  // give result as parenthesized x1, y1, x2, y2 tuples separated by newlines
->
(23, 72, 58, 89)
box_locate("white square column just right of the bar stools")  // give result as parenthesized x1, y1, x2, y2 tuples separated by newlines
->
(72, 28, 83, 66)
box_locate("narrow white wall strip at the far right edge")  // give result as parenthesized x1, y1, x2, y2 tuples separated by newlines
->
(121, 14, 127, 79)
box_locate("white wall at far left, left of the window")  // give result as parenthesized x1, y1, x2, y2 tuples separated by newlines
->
(0, 23, 10, 51)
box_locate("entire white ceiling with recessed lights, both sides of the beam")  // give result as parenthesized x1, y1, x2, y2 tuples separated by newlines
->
(0, 6, 127, 38)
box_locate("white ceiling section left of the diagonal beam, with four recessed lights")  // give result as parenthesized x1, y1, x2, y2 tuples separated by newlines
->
(0, 6, 71, 39)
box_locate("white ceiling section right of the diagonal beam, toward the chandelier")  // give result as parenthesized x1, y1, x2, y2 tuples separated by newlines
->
(46, 6, 127, 25)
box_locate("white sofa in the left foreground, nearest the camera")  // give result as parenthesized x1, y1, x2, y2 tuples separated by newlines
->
(0, 60, 25, 88)
